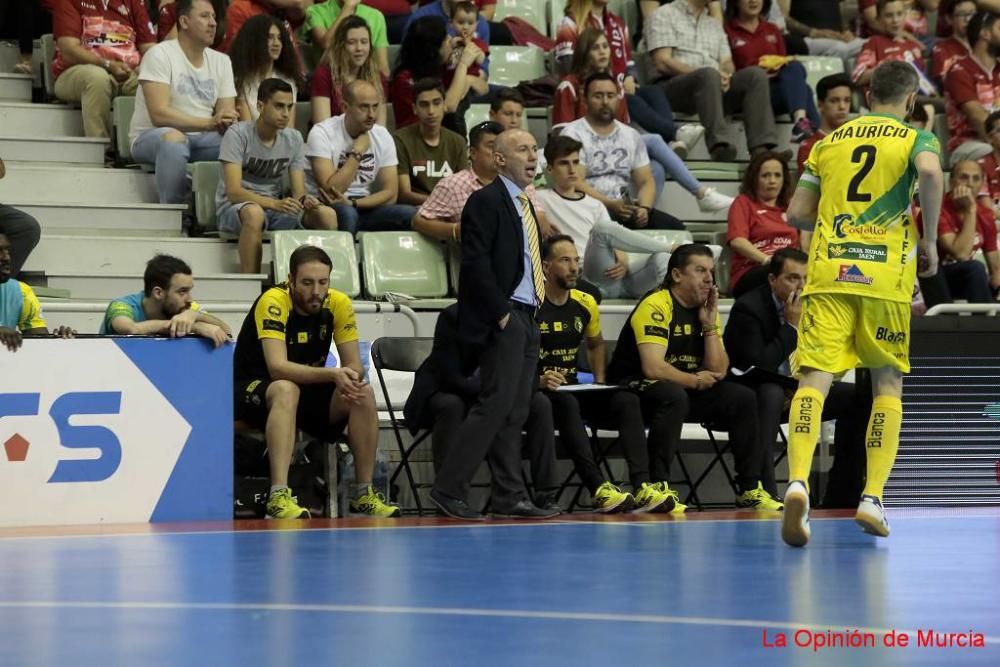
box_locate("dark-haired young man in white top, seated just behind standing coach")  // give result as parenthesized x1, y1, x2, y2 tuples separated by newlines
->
(536, 135, 673, 300)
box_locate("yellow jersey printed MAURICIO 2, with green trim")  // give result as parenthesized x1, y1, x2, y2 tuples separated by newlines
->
(798, 114, 941, 303)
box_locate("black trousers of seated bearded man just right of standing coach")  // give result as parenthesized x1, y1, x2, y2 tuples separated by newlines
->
(539, 390, 649, 494)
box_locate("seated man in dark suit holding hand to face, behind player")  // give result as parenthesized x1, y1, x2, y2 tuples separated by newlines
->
(723, 248, 872, 508)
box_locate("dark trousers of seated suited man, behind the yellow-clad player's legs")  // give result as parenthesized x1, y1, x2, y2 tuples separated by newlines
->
(754, 380, 872, 508)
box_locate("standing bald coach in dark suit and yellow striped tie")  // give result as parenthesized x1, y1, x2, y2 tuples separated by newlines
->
(431, 130, 559, 519)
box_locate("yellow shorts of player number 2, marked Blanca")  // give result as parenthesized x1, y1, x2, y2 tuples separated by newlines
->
(794, 294, 910, 375)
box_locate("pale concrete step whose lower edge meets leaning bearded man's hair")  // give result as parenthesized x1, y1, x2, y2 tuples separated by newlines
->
(24, 234, 271, 279)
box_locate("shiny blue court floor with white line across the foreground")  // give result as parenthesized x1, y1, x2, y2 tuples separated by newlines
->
(0, 510, 1000, 667)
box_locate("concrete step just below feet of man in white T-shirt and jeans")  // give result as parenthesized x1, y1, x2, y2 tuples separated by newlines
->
(13, 199, 187, 236)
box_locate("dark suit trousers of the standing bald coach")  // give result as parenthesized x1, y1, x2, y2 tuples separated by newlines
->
(434, 309, 539, 509)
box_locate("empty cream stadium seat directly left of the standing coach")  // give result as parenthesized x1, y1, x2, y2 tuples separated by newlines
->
(358, 232, 448, 300)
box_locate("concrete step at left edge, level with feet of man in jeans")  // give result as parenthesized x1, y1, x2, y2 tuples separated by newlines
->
(0, 163, 159, 204)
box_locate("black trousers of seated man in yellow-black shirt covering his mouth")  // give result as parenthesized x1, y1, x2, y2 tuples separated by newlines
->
(639, 381, 761, 493)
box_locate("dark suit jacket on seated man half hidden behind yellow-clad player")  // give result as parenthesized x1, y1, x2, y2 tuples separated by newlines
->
(723, 285, 798, 373)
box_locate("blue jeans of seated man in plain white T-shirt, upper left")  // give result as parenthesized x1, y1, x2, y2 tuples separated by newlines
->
(132, 127, 222, 204)
